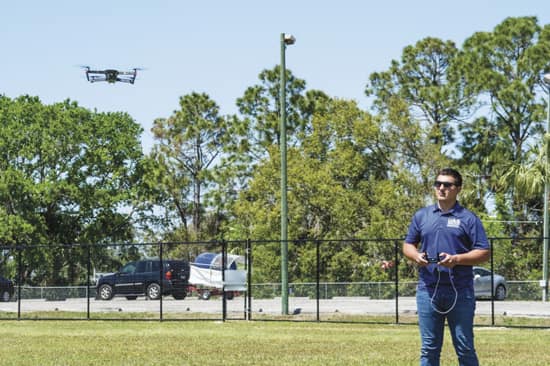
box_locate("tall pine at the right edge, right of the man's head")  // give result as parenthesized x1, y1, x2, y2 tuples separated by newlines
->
(459, 17, 550, 234)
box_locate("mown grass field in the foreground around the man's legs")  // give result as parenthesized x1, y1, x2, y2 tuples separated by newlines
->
(0, 320, 550, 366)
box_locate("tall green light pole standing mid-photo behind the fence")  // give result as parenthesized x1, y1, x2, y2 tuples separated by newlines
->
(279, 33, 296, 315)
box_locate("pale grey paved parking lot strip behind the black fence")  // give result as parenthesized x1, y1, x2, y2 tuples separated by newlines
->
(0, 296, 550, 317)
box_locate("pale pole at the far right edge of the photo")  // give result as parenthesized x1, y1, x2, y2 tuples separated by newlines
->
(542, 73, 550, 301)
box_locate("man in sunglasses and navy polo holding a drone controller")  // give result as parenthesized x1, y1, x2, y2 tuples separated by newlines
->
(403, 168, 490, 366)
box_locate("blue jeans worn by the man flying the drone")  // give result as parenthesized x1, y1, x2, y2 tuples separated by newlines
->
(416, 286, 479, 366)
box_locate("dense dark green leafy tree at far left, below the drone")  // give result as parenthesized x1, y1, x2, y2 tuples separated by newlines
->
(0, 96, 146, 283)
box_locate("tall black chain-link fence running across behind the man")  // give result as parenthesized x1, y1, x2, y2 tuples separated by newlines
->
(0, 238, 550, 327)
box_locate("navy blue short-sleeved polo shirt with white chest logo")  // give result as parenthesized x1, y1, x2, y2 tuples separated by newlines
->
(405, 202, 490, 289)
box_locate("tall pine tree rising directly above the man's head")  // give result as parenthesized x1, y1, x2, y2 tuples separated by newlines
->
(365, 37, 468, 201)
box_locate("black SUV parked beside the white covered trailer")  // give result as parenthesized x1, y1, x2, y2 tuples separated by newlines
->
(96, 259, 190, 300)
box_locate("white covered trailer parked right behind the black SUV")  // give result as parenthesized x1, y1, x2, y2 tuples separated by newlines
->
(189, 252, 246, 300)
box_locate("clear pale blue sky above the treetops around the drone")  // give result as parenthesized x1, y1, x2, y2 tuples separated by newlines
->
(0, 0, 550, 152)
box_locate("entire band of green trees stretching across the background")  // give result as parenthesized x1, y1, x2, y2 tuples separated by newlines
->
(0, 17, 550, 291)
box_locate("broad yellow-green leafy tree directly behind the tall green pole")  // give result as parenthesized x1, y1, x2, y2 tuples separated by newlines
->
(232, 99, 417, 280)
